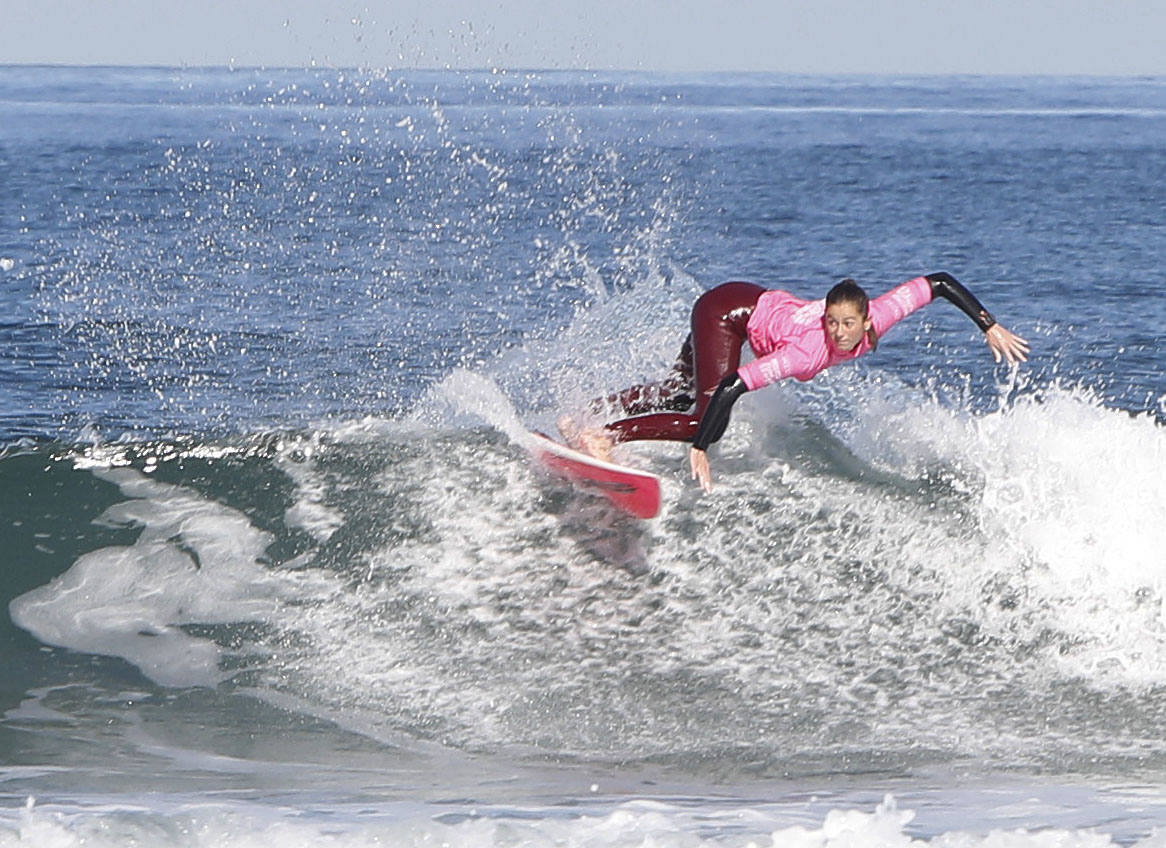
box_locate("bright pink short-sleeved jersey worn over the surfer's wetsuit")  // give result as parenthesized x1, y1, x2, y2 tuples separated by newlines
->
(737, 276, 932, 391)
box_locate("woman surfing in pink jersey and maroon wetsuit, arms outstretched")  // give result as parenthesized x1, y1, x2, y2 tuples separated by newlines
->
(560, 272, 1028, 491)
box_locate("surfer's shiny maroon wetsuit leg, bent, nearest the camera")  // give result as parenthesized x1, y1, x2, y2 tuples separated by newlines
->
(606, 282, 765, 442)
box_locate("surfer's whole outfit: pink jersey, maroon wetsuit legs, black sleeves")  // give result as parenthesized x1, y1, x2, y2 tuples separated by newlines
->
(595, 272, 996, 450)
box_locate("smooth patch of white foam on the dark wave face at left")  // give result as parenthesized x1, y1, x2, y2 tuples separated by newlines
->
(9, 468, 328, 686)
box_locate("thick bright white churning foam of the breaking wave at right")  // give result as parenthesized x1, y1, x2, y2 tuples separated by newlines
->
(844, 386, 1166, 686)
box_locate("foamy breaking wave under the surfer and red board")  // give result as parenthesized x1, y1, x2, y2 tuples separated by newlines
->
(9, 340, 1166, 775)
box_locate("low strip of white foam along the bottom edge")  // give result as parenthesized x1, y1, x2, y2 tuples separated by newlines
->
(0, 797, 1166, 848)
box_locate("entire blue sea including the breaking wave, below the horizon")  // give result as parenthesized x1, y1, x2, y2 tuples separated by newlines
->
(0, 66, 1166, 848)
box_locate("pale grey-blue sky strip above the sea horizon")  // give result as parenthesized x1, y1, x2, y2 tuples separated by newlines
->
(0, 0, 1166, 76)
